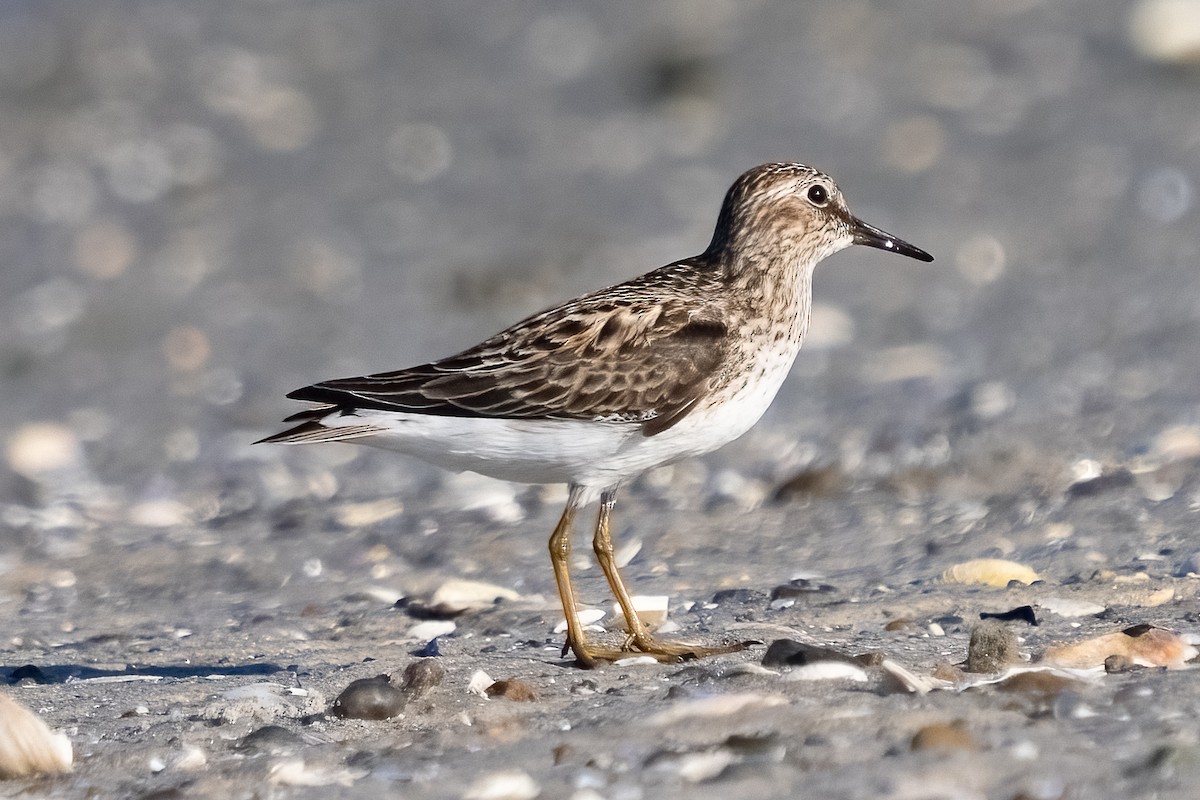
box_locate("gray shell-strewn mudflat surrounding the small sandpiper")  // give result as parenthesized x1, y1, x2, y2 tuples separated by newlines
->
(0, 0, 1200, 800)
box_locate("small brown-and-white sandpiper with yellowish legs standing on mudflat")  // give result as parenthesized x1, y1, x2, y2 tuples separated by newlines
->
(263, 163, 934, 667)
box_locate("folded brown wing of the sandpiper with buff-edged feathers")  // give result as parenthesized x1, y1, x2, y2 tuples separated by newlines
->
(281, 273, 727, 435)
